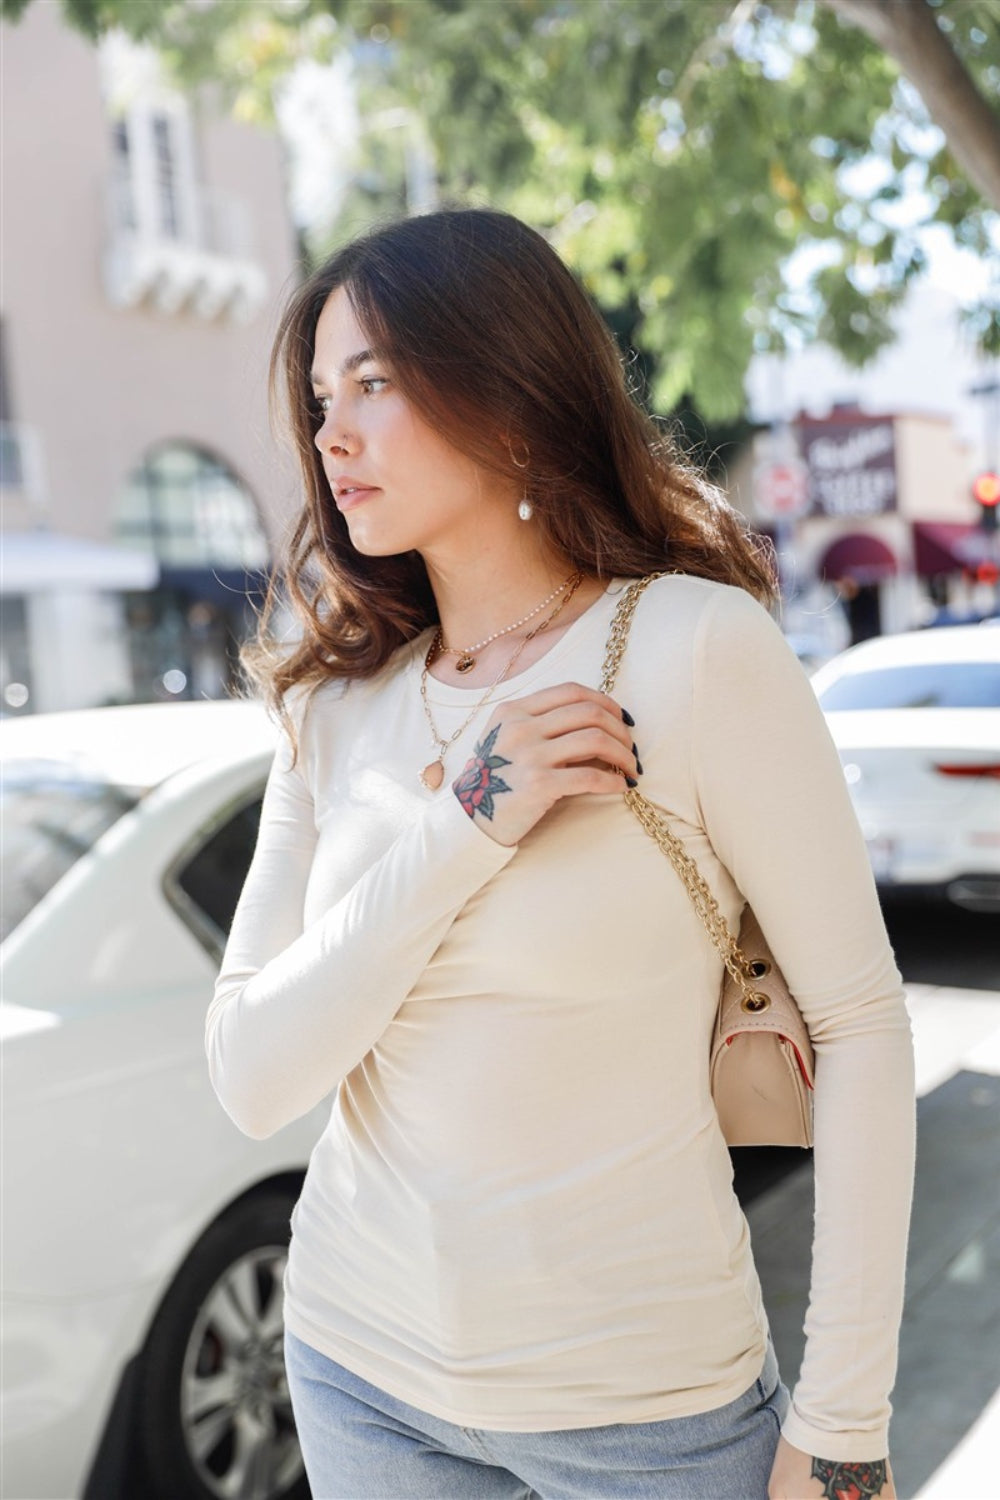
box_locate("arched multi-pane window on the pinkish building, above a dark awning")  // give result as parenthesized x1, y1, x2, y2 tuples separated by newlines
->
(114, 443, 270, 570)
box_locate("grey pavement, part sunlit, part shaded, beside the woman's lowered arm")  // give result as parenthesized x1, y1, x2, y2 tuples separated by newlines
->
(747, 984, 1000, 1500)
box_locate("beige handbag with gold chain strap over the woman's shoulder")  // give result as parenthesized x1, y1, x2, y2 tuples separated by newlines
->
(601, 573, 814, 1146)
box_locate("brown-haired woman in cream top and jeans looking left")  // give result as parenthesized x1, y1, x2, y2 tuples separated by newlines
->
(207, 210, 913, 1500)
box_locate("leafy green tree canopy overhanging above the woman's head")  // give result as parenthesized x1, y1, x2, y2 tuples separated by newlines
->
(4, 0, 1000, 422)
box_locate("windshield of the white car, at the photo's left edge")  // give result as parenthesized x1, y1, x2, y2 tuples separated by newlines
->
(0, 761, 139, 939)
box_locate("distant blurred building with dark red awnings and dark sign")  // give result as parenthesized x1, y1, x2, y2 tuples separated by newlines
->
(730, 404, 1000, 654)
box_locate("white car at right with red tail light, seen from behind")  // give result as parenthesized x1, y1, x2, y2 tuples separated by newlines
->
(811, 624, 1000, 912)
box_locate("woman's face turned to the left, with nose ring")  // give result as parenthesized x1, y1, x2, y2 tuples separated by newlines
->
(312, 288, 517, 560)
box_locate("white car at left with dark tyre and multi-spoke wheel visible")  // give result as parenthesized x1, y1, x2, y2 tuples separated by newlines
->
(0, 704, 324, 1500)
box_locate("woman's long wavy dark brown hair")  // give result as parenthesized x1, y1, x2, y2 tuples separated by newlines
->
(243, 209, 775, 717)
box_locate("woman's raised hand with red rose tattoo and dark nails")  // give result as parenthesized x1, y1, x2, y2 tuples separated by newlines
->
(451, 683, 640, 848)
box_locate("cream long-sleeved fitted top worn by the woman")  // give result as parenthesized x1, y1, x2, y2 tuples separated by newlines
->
(207, 576, 913, 1461)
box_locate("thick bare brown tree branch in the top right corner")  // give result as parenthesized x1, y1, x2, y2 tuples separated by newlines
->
(823, 0, 1000, 210)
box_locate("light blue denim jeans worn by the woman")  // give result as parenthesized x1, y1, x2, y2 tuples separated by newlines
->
(285, 1334, 789, 1500)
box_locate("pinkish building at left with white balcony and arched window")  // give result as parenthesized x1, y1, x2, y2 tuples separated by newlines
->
(0, 5, 298, 714)
